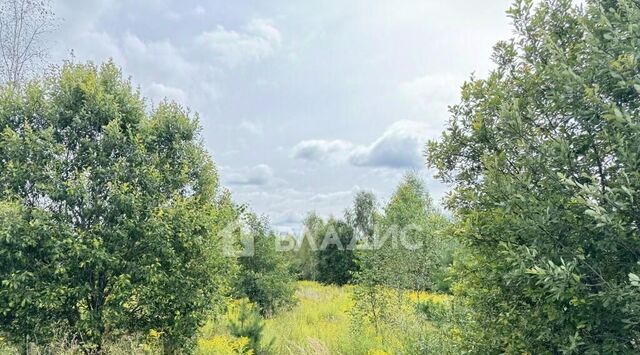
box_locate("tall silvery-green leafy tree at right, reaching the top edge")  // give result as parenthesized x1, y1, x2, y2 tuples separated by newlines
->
(428, 0, 640, 354)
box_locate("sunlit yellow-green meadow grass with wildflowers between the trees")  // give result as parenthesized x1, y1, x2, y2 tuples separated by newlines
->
(198, 281, 448, 355)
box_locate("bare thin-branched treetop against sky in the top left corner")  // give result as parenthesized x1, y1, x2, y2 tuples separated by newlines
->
(0, 0, 55, 86)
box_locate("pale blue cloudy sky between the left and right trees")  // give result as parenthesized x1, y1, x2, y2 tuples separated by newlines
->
(51, 0, 512, 232)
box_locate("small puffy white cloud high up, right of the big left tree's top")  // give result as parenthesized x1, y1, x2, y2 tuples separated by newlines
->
(195, 19, 282, 66)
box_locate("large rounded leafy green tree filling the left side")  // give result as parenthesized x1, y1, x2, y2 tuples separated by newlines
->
(0, 63, 229, 352)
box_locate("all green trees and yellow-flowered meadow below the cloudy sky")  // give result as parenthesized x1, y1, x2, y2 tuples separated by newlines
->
(0, 0, 640, 354)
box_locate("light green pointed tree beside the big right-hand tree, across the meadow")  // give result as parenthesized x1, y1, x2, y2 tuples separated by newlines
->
(357, 173, 454, 290)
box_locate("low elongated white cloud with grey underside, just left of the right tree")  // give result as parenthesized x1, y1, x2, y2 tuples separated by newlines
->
(292, 120, 439, 169)
